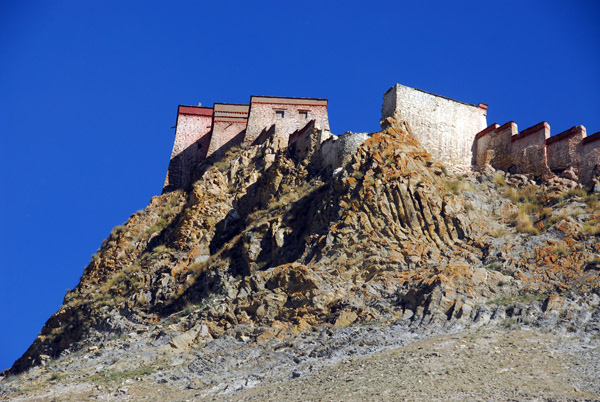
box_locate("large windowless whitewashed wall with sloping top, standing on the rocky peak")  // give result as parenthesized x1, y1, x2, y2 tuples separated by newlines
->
(381, 84, 487, 166)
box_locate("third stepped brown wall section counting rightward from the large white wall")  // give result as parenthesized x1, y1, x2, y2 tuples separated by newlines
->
(546, 126, 585, 173)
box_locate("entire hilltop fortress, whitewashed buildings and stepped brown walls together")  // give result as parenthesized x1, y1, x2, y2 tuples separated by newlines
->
(163, 84, 600, 192)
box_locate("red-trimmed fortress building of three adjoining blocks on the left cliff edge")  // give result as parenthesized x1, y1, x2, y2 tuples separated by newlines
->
(163, 96, 329, 192)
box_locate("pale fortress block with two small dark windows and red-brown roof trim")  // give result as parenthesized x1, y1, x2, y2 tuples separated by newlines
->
(244, 96, 329, 145)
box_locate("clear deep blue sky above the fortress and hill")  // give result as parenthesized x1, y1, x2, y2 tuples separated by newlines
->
(0, 0, 600, 370)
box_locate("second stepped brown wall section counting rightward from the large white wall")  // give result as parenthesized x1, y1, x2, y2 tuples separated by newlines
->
(511, 121, 550, 177)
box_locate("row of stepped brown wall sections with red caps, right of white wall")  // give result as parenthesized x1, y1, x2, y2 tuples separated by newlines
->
(474, 118, 600, 184)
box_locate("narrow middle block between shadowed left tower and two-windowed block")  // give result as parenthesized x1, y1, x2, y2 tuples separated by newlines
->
(206, 103, 249, 157)
